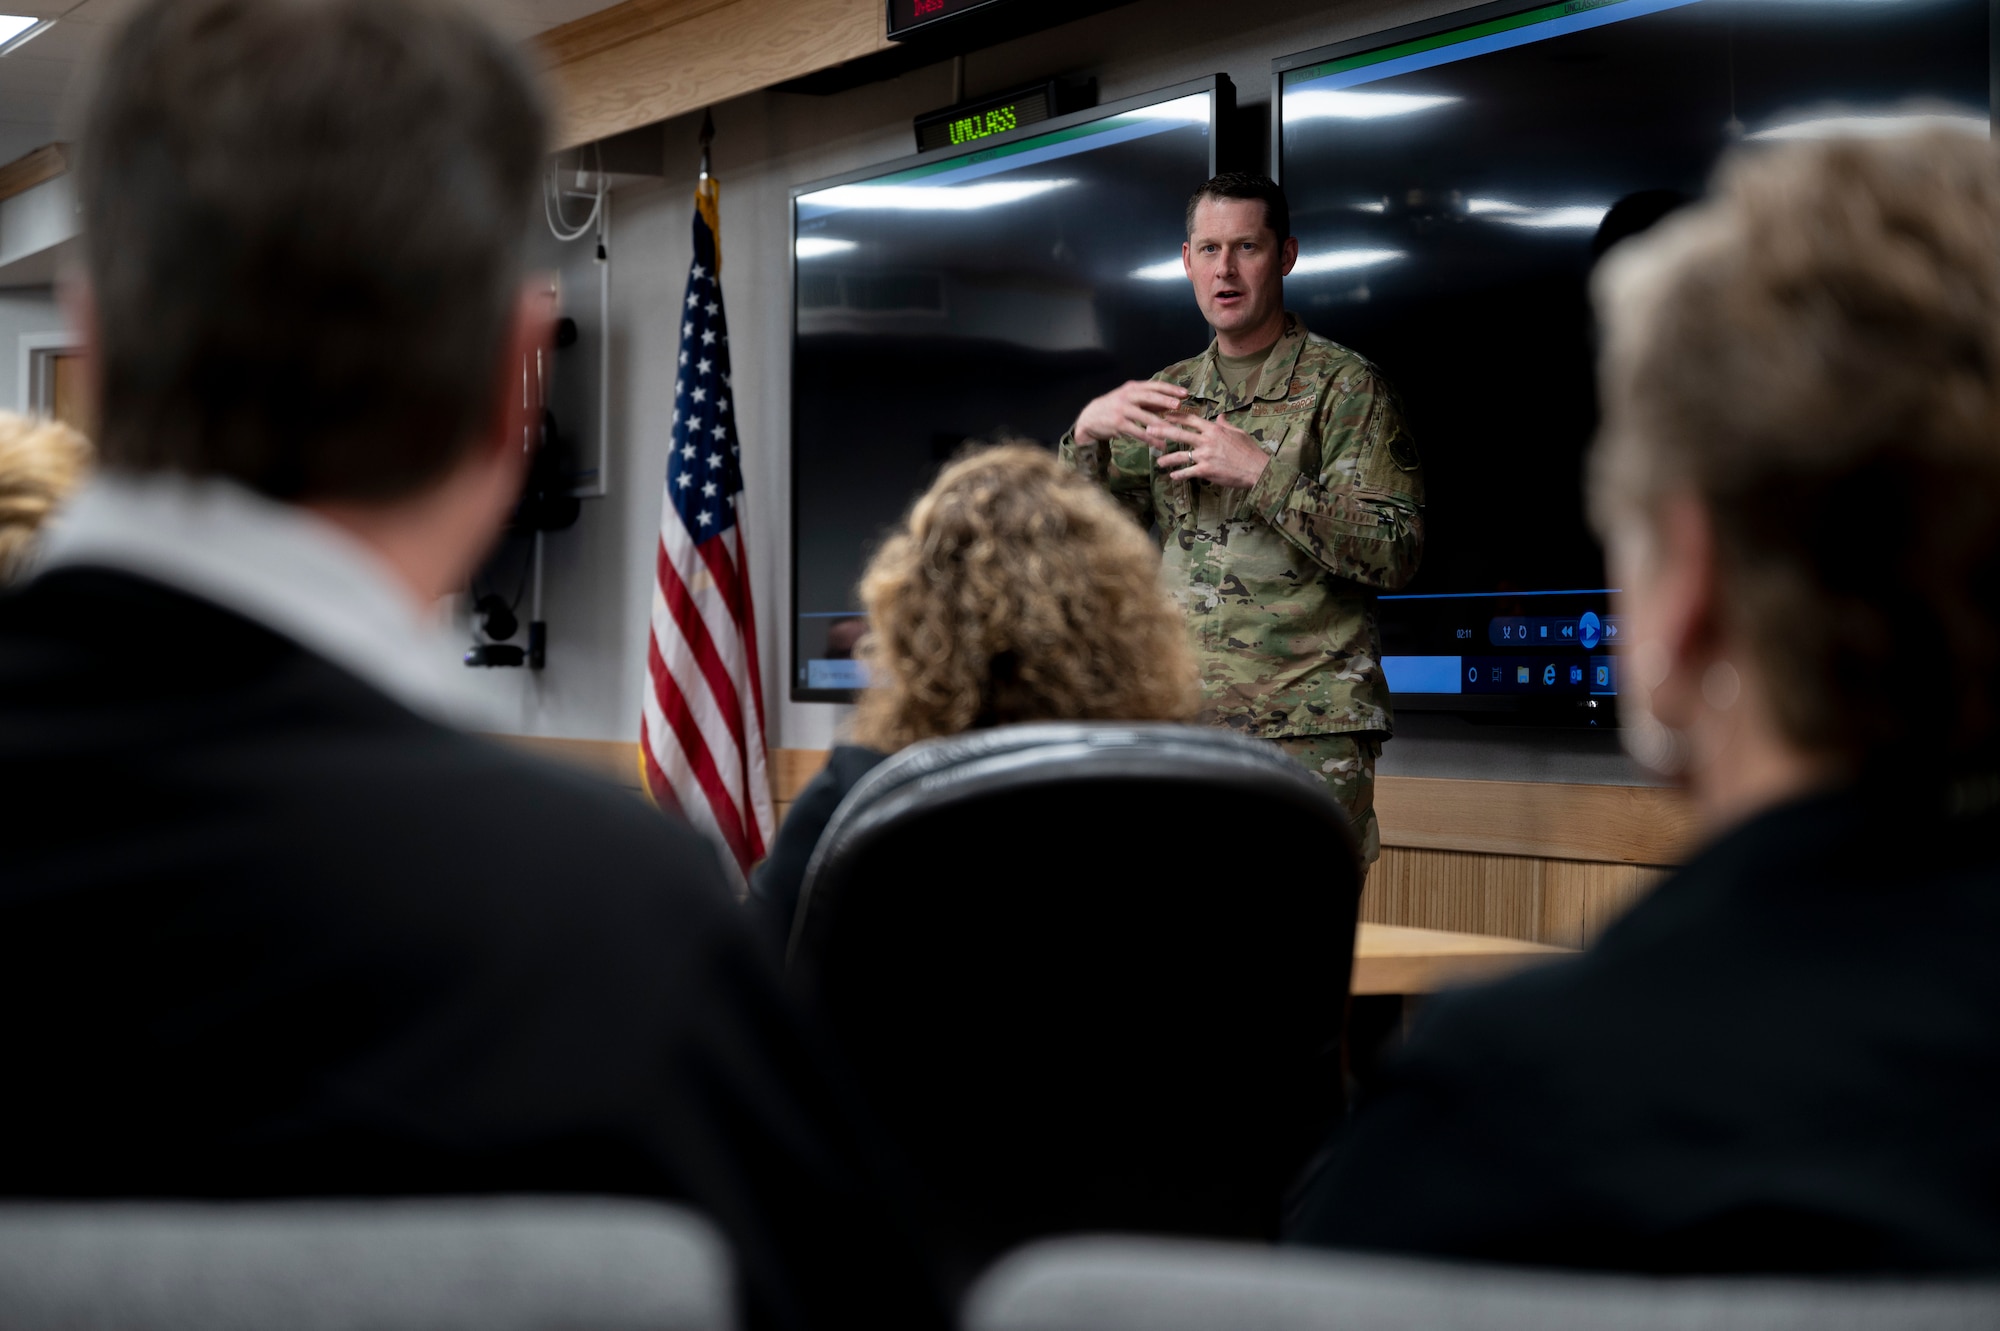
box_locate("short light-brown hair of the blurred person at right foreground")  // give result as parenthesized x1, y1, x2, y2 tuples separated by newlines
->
(1592, 132, 2000, 765)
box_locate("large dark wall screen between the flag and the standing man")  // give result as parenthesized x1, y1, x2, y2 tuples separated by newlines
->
(792, 78, 1230, 701)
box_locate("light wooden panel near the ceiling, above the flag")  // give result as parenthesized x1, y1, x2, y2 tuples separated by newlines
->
(538, 0, 890, 148)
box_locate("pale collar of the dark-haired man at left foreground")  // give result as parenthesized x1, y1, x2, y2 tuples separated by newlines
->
(36, 472, 486, 727)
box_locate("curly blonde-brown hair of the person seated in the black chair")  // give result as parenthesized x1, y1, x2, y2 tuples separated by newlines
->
(854, 444, 1200, 751)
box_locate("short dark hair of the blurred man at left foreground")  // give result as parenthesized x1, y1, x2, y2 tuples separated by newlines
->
(78, 0, 546, 500)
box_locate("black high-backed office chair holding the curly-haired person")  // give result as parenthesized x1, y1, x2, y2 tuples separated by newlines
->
(790, 723, 1360, 1275)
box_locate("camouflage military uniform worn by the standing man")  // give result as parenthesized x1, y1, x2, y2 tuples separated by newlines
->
(1062, 314, 1424, 859)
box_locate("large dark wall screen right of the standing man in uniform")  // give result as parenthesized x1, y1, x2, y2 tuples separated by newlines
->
(1274, 0, 1992, 717)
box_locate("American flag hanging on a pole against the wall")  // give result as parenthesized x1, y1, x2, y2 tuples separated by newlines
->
(640, 176, 774, 871)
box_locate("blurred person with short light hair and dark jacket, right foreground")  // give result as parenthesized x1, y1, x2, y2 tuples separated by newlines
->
(1292, 132, 2000, 1271)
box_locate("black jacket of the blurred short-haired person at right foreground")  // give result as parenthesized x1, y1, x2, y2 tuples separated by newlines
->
(1298, 785, 2000, 1271)
